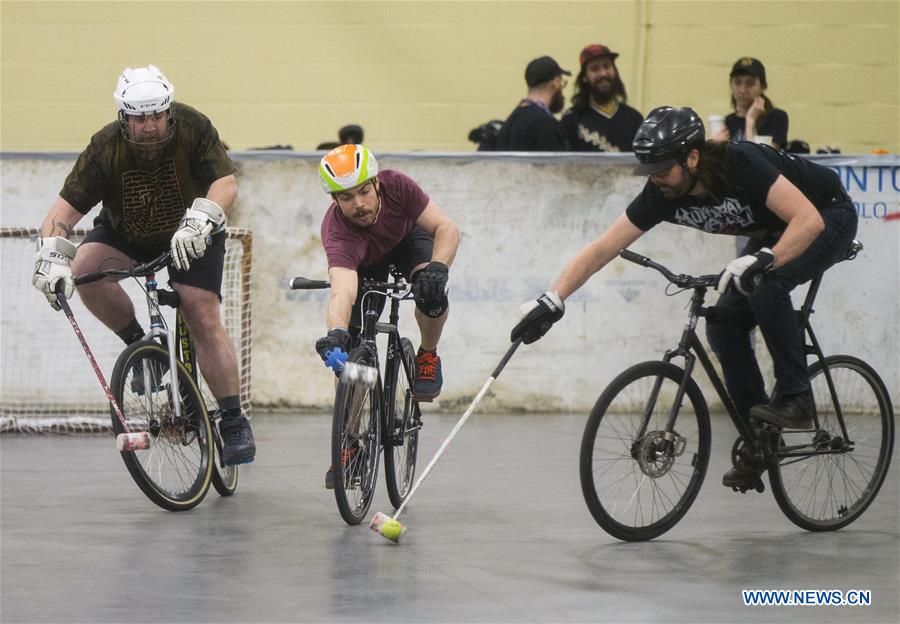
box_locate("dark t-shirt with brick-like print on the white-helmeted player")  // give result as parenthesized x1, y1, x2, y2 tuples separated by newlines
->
(59, 103, 235, 248)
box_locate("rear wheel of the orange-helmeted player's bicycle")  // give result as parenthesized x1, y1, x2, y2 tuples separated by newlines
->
(384, 338, 422, 509)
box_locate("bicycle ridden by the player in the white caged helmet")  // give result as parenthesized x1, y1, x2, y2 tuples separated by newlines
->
(66, 251, 238, 511)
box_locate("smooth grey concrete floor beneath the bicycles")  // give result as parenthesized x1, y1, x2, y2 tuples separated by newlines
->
(0, 414, 900, 622)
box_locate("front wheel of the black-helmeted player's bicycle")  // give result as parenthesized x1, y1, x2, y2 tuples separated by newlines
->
(580, 362, 710, 541)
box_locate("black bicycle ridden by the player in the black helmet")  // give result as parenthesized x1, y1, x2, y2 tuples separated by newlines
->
(580, 241, 894, 541)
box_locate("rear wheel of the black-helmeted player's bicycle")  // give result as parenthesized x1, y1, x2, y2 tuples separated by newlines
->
(769, 355, 894, 531)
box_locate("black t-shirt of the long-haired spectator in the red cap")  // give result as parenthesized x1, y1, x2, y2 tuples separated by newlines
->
(560, 104, 644, 152)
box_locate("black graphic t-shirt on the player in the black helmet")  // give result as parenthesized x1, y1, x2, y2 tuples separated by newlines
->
(625, 141, 848, 237)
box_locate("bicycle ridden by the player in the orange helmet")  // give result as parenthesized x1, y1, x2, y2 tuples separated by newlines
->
(290, 265, 422, 525)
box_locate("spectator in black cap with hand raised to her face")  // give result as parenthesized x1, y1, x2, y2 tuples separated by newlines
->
(713, 56, 788, 149)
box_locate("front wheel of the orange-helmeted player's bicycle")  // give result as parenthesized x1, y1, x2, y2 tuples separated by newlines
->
(331, 347, 381, 525)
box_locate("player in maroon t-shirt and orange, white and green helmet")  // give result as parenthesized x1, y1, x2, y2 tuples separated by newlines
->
(316, 145, 459, 487)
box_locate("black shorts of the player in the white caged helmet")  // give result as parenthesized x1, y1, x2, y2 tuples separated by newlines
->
(81, 219, 225, 300)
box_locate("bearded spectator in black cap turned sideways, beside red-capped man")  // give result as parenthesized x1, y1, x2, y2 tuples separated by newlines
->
(496, 56, 572, 152)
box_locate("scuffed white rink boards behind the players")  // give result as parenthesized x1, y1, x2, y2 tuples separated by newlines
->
(0, 152, 900, 411)
